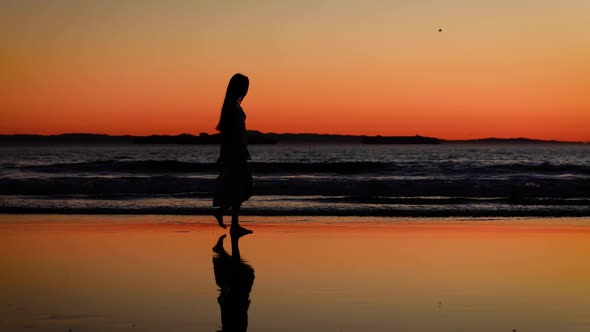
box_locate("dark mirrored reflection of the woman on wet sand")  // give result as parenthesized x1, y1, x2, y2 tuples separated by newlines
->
(213, 235, 254, 332)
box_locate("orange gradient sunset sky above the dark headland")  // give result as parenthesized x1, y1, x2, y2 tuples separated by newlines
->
(0, 0, 590, 141)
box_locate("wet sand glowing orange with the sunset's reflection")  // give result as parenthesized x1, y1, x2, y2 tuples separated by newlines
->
(0, 215, 590, 332)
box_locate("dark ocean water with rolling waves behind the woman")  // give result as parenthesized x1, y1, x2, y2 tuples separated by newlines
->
(0, 144, 590, 216)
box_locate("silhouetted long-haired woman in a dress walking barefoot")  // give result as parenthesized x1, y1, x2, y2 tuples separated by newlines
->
(213, 74, 252, 234)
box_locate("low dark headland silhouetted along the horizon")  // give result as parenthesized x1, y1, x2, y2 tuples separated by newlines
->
(0, 130, 590, 146)
